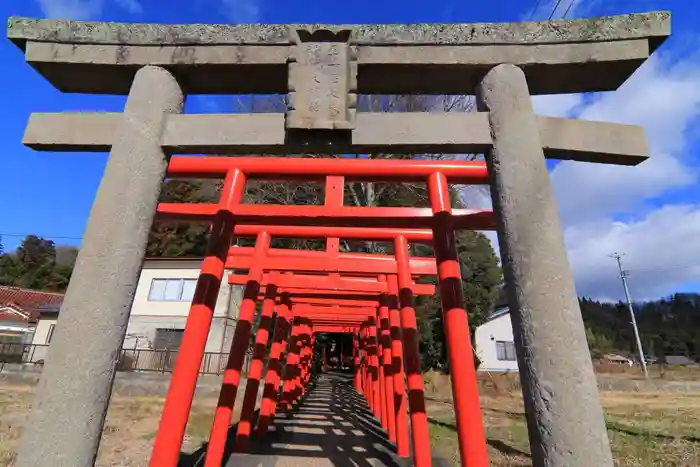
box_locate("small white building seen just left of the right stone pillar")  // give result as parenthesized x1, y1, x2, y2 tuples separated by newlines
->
(474, 307, 518, 372)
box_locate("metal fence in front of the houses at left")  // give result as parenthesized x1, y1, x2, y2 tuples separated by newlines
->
(0, 343, 250, 375)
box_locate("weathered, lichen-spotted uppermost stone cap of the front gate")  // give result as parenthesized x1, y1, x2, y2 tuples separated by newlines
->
(7, 11, 671, 51)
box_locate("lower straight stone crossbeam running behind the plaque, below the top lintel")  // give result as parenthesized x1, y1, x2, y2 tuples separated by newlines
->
(23, 112, 649, 165)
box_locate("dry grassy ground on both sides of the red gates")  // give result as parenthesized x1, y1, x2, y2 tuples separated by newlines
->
(0, 374, 700, 467)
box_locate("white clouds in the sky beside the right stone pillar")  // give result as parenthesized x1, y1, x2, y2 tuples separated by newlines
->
(533, 50, 700, 299)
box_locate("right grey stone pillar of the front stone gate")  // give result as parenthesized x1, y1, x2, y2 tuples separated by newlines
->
(476, 65, 613, 467)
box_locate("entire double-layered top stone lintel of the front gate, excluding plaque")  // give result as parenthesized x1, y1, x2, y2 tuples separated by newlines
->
(8, 12, 670, 95)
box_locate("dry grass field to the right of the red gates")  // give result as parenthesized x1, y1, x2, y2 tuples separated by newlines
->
(426, 371, 700, 467)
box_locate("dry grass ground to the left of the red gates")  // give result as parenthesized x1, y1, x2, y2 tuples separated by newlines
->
(0, 385, 231, 467)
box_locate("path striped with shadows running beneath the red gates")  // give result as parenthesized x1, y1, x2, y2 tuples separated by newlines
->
(179, 374, 410, 467)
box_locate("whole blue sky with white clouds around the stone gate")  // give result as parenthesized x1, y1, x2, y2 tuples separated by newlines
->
(0, 0, 700, 299)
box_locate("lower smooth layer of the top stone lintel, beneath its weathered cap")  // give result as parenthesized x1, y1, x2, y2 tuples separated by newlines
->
(20, 39, 650, 94)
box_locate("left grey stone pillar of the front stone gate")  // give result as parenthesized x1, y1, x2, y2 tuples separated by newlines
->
(17, 66, 184, 467)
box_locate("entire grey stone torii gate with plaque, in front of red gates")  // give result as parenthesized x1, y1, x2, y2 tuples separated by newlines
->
(8, 12, 670, 467)
